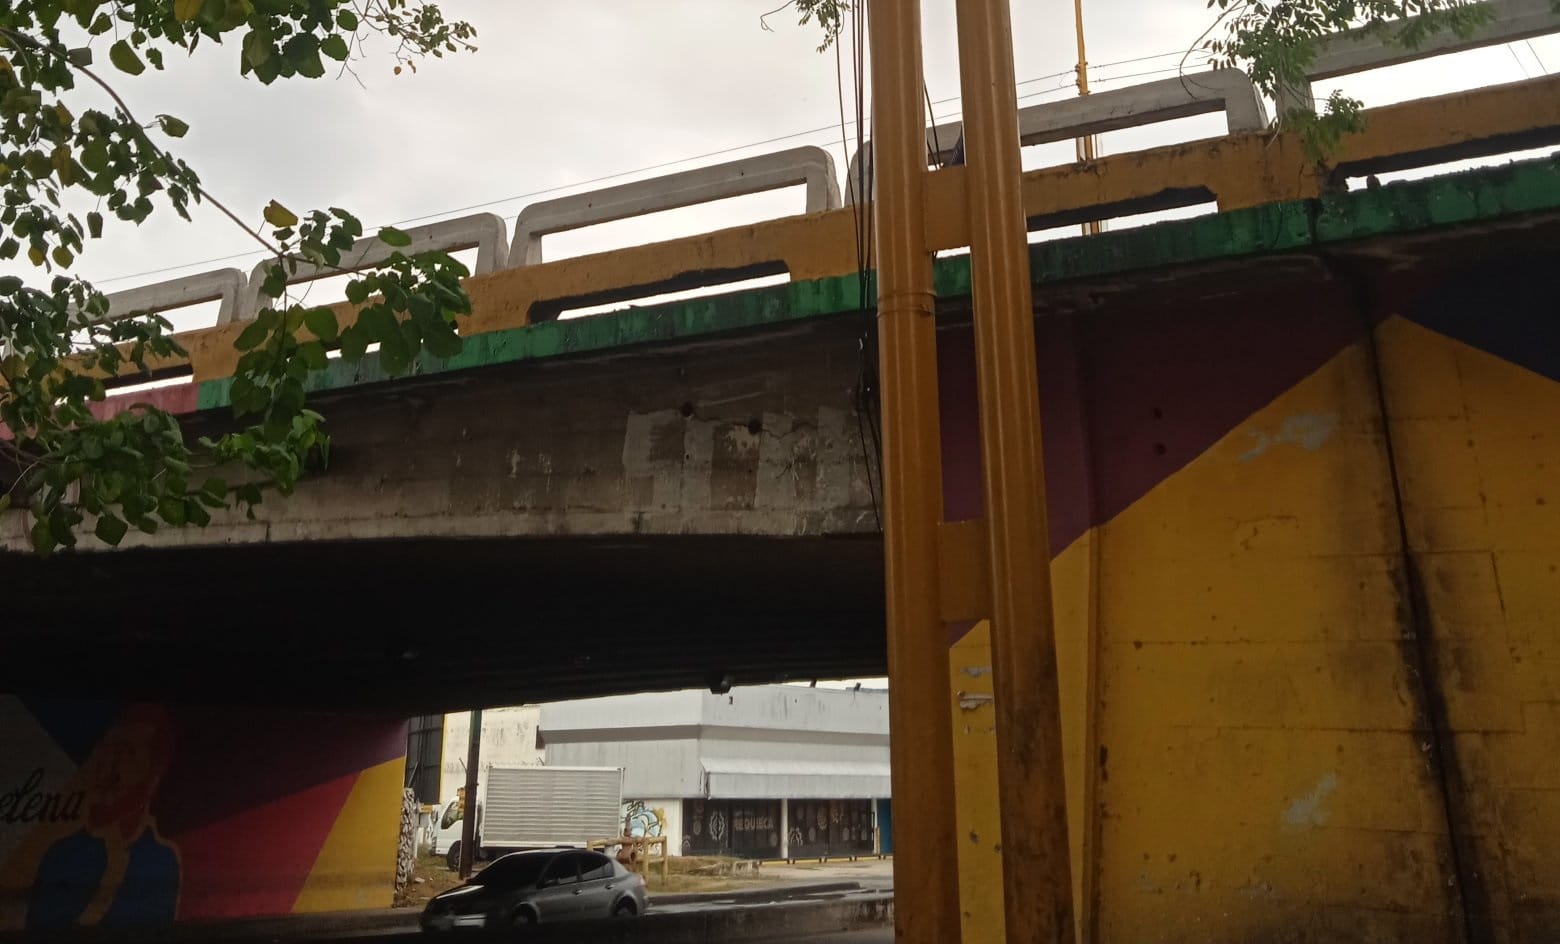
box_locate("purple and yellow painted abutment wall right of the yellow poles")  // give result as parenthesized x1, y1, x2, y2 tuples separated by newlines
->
(939, 251, 1560, 941)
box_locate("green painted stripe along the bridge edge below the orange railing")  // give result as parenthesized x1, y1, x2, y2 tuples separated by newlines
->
(198, 156, 1560, 410)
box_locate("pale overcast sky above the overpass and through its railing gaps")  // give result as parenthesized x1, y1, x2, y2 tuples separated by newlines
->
(3, 0, 1560, 319)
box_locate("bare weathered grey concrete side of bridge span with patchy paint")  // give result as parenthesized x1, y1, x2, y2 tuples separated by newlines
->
(3, 318, 877, 549)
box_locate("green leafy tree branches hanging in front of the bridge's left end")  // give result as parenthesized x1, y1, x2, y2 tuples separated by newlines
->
(0, 0, 474, 554)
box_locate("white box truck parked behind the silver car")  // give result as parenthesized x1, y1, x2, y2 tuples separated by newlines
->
(431, 768, 622, 868)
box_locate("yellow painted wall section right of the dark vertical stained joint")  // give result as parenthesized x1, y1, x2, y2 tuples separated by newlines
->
(1377, 312, 1560, 942)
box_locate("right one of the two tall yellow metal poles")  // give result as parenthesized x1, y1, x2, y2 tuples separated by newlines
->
(958, 0, 1073, 944)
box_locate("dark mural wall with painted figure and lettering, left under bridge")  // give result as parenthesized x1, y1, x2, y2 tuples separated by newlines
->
(0, 696, 406, 930)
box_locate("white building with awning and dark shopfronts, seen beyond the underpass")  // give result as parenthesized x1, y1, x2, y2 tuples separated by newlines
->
(542, 685, 892, 858)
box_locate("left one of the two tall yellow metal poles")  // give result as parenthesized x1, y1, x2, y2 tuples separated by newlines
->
(867, 0, 959, 944)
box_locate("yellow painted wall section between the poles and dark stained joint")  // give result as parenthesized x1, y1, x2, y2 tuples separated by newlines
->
(1058, 342, 1457, 942)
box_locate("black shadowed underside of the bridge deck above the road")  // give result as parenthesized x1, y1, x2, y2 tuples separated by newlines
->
(0, 535, 885, 713)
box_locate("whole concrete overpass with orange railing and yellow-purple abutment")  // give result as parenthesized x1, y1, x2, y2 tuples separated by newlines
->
(0, 7, 1560, 941)
